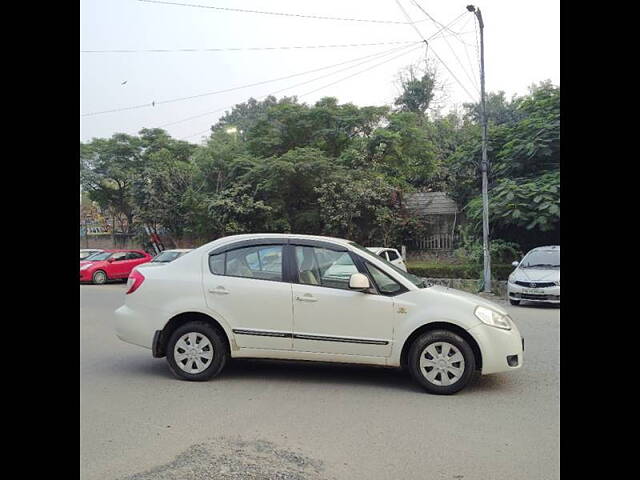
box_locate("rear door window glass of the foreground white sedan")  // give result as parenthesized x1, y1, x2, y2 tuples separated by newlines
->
(221, 245, 282, 282)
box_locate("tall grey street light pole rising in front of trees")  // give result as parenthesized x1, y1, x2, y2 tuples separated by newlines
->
(467, 5, 491, 292)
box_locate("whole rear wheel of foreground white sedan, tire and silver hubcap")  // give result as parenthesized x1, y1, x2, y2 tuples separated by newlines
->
(167, 322, 228, 381)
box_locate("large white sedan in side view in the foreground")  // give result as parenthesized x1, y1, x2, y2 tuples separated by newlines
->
(115, 234, 524, 394)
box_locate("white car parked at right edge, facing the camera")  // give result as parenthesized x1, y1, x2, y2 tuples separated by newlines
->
(507, 245, 560, 305)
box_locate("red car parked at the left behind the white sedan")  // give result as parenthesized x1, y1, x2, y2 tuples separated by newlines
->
(80, 250, 153, 285)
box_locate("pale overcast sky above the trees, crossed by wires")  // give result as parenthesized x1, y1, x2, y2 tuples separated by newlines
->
(80, 0, 560, 143)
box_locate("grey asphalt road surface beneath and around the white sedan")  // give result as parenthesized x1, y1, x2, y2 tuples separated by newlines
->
(80, 284, 560, 480)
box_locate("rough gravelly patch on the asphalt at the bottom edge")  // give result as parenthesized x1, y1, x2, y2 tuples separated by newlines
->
(121, 438, 328, 480)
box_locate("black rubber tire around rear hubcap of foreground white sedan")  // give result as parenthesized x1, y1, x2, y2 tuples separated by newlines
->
(166, 321, 229, 382)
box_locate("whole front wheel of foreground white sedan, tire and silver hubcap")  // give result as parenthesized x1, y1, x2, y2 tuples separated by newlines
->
(407, 330, 476, 395)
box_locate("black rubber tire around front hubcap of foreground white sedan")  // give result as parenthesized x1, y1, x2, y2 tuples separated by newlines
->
(407, 330, 476, 395)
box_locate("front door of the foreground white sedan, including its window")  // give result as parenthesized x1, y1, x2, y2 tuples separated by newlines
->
(292, 244, 394, 357)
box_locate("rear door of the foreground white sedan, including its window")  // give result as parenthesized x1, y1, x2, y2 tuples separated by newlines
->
(203, 242, 293, 350)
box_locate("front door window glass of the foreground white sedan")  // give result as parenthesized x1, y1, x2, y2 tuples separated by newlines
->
(295, 246, 358, 290)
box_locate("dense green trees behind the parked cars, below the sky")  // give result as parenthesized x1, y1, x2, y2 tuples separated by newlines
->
(80, 73, 560, 251)
